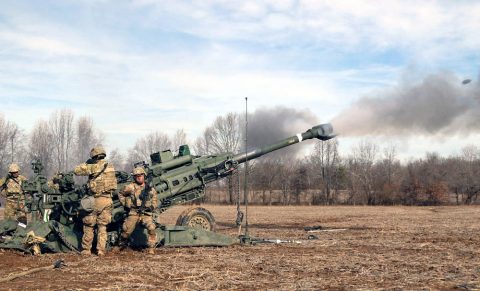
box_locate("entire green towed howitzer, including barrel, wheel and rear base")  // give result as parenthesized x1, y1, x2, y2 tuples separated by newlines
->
(0, 124, 335, 253)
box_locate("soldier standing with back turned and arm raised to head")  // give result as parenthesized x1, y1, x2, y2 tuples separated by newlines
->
(73, 147, 117, 256)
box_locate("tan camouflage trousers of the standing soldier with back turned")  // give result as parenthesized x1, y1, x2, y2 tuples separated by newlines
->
(82, 197, 113, 252)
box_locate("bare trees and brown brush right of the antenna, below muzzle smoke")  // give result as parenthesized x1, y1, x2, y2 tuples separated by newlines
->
(214, 139, 480, 205)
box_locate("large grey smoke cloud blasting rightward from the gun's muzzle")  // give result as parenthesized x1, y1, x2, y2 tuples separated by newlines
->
(332, 73, 480, 136)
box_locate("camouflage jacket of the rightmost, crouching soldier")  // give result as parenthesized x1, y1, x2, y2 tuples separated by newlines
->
(118, 182, 158, 212)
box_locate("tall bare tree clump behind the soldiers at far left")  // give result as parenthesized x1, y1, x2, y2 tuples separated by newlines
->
(0, 109, 104, 176)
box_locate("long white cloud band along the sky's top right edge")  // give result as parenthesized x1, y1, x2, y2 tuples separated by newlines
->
(129, 0, 480, 59)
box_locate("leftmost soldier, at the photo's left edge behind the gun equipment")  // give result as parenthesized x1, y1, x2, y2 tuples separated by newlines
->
(1, 164, 27, 223)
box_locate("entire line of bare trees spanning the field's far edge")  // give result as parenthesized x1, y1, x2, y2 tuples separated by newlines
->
(0, 109, 480, 205)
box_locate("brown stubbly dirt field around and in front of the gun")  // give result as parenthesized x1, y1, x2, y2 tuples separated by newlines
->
(0, 205, 480, 290)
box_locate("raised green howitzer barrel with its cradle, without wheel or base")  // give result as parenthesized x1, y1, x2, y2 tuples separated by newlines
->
(148, 124, 335, 211)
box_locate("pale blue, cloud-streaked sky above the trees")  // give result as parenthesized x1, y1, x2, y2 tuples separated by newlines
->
(0, 0, 480, 159)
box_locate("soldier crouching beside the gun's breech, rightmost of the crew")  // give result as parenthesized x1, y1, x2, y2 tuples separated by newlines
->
(119, 167, 158, 254)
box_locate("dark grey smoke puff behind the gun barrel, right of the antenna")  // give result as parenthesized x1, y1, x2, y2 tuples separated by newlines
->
(242, 106, 317, 157)
